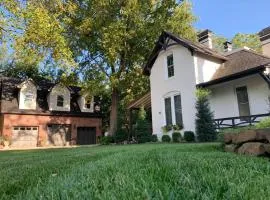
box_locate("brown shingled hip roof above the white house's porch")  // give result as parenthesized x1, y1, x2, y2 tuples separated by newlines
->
(197, 49, 270, 87)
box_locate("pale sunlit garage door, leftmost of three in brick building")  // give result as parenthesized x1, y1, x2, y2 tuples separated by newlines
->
(11, 126, 38, 147)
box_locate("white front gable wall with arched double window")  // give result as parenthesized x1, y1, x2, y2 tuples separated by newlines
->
(150, 45, 196, 137)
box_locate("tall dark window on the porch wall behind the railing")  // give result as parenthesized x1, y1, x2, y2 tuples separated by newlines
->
(236, 86, 250, 121)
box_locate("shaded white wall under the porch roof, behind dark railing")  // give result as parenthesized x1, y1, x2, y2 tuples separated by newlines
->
(209, 75, 270, 118)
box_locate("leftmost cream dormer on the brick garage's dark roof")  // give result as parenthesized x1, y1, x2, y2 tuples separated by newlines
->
(19, 80, 37, 110)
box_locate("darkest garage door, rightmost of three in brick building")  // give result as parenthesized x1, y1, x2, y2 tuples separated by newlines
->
(77, 127, 96, 145)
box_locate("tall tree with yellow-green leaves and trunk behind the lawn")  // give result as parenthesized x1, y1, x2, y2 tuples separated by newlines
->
(3, 0, 196, 135)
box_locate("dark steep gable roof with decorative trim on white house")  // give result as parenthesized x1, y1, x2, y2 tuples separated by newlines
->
(144, 31, 227, 75)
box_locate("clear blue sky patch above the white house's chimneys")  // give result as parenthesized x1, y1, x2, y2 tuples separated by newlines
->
(192, 0, 270, 39)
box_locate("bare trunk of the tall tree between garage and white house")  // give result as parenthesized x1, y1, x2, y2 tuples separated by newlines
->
(109, 88, 119, 136)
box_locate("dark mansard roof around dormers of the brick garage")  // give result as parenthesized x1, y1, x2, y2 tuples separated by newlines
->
(0, 77, 99, 117)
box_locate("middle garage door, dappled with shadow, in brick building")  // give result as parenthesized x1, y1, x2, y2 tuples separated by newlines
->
(47, 124, 71, 146)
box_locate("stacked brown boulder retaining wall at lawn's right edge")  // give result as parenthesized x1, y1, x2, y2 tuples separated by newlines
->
(224, 129, 270, 156)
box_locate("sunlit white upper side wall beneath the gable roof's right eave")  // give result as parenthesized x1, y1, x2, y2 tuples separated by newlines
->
(194, 53, 222, 84)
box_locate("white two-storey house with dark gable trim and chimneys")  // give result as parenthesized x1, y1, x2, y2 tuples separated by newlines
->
(130, 28, 270, 136)
